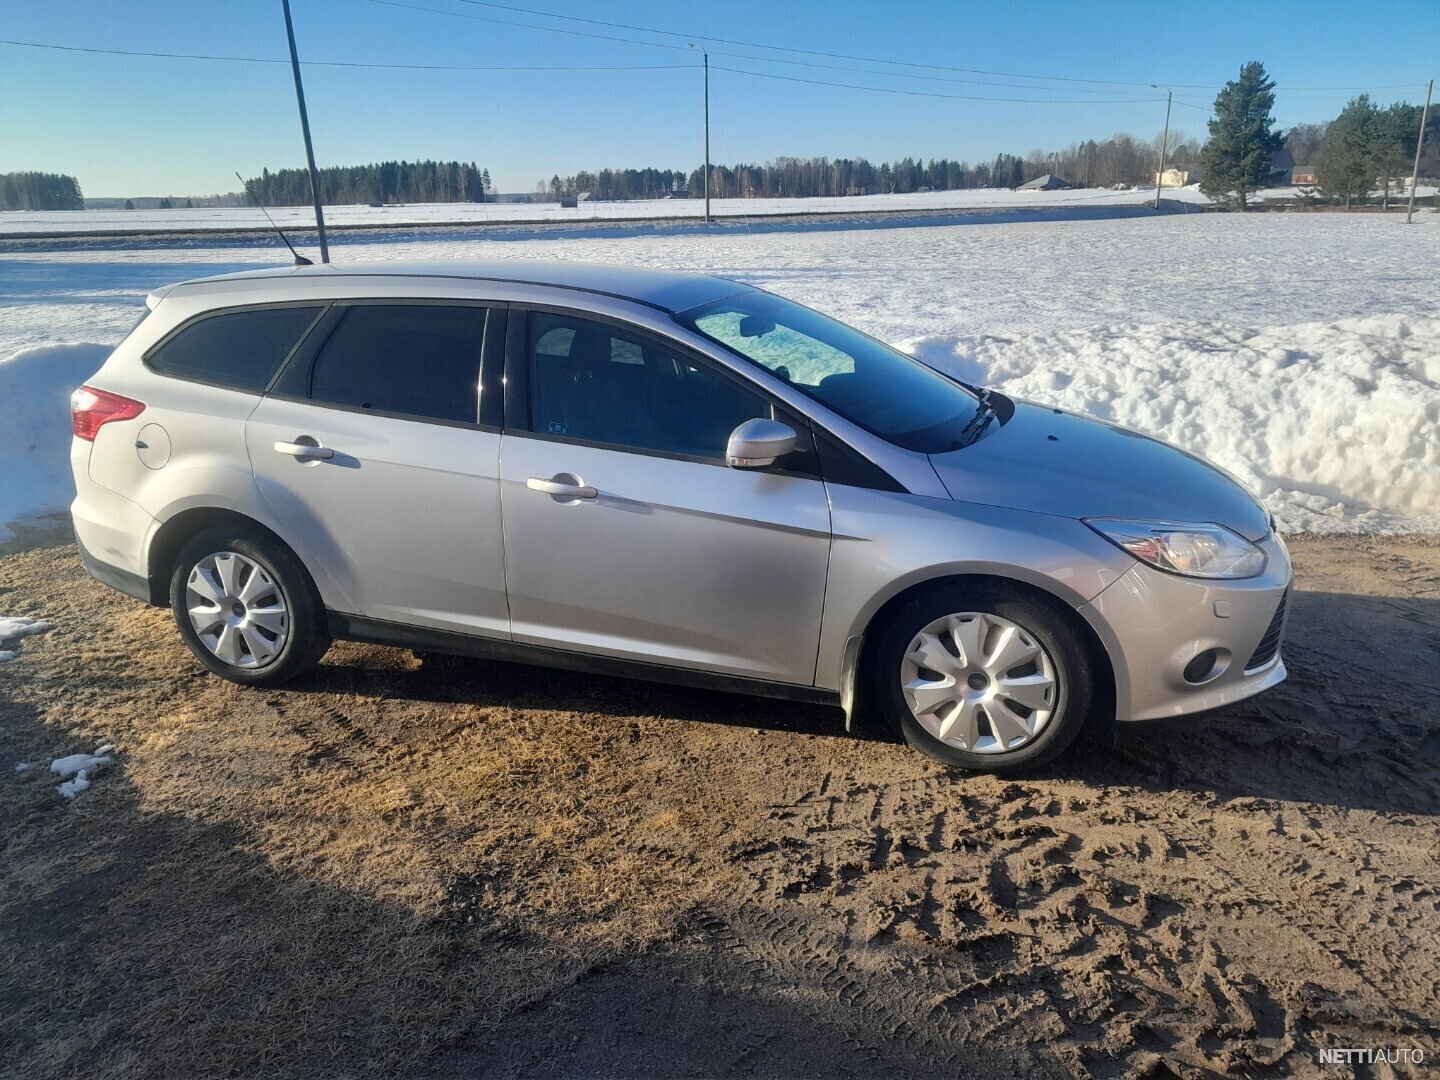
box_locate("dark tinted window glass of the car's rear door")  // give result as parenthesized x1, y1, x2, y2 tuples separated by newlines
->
(310, 304, 485, 423)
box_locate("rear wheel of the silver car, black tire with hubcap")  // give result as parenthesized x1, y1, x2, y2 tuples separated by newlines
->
(170, 526, 331, 687)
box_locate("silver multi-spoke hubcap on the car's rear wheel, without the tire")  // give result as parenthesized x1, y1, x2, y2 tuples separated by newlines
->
(184, 552, 289, 668)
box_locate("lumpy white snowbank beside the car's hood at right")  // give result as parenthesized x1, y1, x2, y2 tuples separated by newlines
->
(904, 315, 1440, 531)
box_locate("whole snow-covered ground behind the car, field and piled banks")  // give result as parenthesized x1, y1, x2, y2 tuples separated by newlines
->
(0, 208, 1440, 531)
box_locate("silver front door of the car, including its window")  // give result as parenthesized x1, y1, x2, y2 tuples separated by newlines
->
(501, 311, 831, 685)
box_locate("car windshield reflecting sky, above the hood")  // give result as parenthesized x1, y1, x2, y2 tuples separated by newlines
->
(675, 292, 979, 454)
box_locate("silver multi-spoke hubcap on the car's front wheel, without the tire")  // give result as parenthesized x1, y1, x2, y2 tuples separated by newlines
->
(900, 612, 1058, 753)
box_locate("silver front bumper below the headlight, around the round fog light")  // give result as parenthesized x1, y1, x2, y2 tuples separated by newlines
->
(1080, 537, 1290, 720)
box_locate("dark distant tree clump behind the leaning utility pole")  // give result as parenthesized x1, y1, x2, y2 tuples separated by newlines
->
(246, 161, 490, 206)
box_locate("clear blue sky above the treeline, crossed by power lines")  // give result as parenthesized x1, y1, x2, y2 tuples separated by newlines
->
(0, 0, 1440, 197)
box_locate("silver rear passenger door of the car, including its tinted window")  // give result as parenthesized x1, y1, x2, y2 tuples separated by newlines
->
(246, 300, 510, 636)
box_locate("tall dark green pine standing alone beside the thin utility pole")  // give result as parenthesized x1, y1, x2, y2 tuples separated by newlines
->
(1200, 60, 1282, 213)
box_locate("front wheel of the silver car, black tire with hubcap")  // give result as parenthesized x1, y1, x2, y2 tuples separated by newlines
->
(867, 585, 1093, 773)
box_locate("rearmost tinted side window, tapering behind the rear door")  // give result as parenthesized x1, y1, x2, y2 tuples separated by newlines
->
(145, 307, 321, 390)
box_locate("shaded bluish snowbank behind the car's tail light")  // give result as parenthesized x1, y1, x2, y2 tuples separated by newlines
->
(0, 344, 111, 541)
